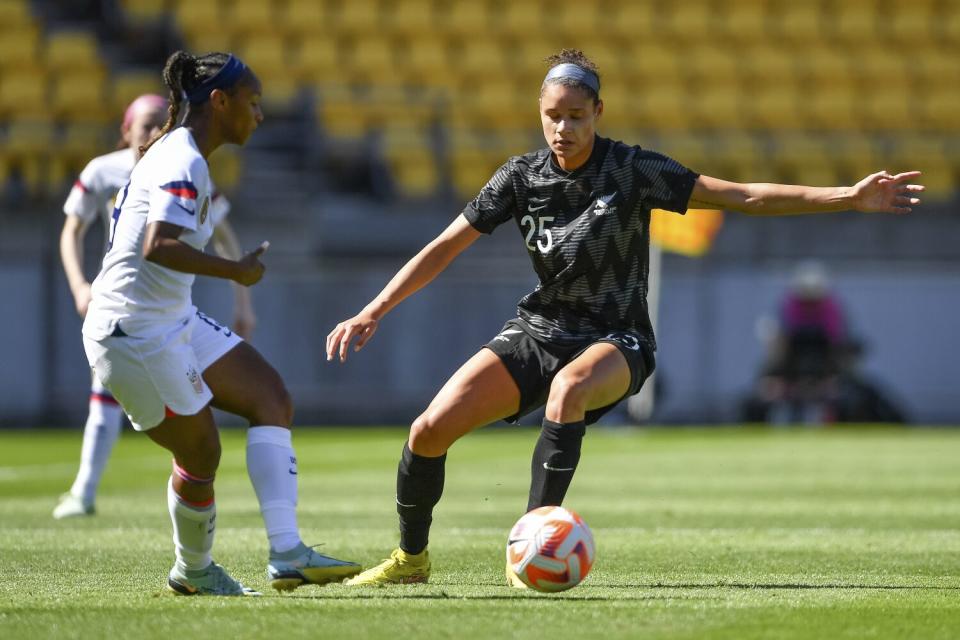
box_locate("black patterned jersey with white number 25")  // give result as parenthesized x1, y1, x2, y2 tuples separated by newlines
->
(463, 137, 698, 351)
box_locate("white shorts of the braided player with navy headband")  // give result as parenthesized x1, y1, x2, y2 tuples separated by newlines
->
(83, 311, 243, 431)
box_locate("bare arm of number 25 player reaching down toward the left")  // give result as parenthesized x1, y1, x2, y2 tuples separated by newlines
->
(327, 215, 480, 362)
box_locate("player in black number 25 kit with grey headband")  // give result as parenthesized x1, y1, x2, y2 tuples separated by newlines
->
(326, 49, 923, 586)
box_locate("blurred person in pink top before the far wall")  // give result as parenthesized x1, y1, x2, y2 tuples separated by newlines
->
(743, 262, 905, 424)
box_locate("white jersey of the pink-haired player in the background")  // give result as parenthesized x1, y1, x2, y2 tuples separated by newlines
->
(63, 148, 230, 255)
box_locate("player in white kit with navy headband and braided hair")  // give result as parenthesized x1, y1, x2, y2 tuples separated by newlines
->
(83, 51, 360, 595)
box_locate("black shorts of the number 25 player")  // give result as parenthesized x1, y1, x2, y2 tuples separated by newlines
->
(485, 318, 655, 424)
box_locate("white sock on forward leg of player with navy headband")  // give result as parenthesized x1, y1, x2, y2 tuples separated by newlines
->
(247, 426, 300, 553)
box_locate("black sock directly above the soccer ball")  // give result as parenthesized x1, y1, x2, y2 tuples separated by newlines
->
(527, 418, 587, 511)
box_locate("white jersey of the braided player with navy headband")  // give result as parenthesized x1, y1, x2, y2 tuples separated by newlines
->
(83, 127, 222, 340)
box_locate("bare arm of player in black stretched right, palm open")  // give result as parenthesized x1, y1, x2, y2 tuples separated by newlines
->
(690, 171, 924, 216)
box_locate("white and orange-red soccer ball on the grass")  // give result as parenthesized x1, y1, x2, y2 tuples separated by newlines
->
(507, 507, 595, 592)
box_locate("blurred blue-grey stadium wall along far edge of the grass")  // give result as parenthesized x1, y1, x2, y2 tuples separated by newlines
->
(0, 255, 960, 426)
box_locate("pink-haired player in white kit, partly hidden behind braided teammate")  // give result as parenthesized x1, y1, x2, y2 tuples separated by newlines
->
(53, 94, 256, 520)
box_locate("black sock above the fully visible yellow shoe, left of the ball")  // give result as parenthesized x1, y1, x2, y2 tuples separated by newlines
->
(397, 444, 447, 553)
